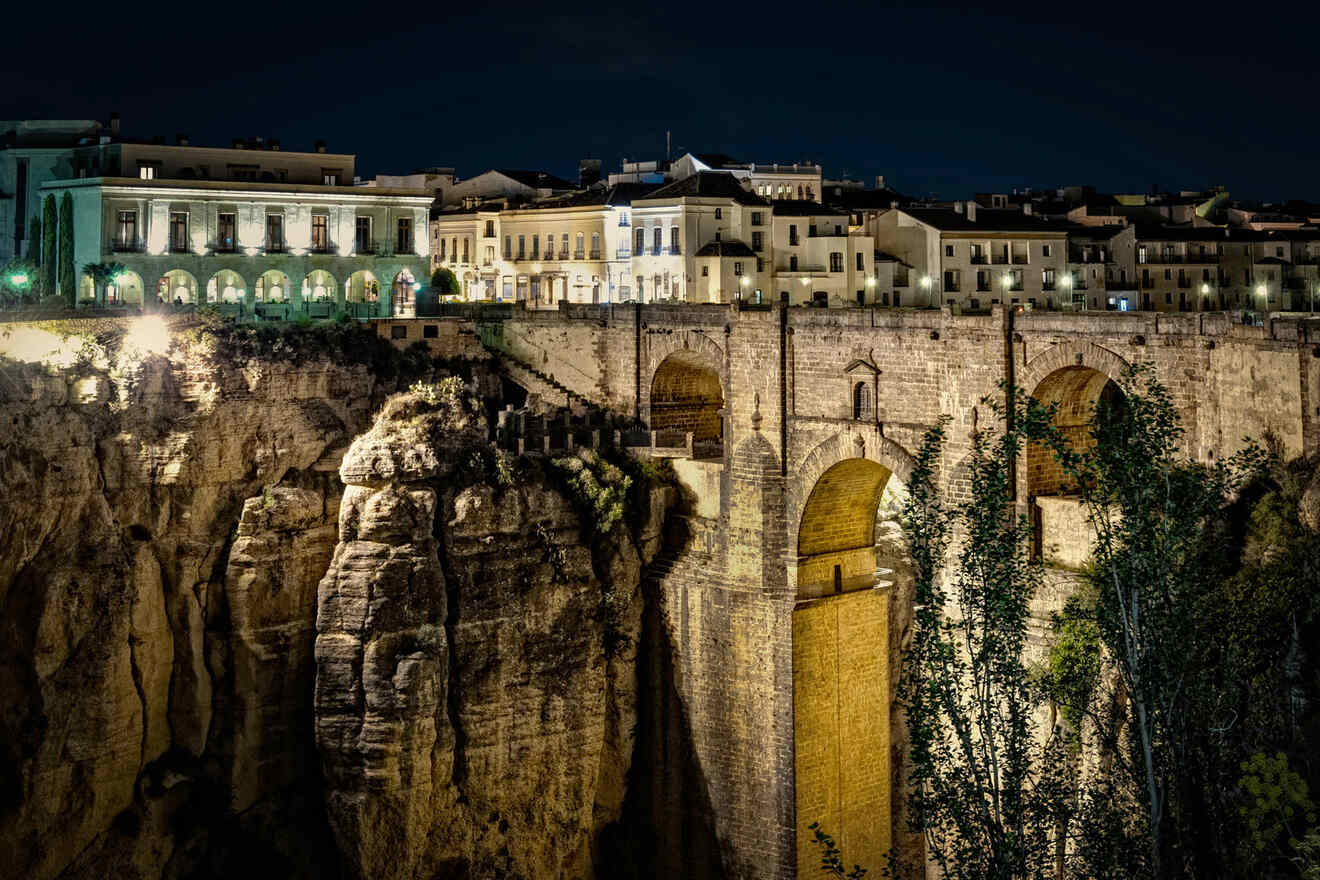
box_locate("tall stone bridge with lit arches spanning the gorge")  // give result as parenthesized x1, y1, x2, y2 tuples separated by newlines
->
(478, 305, 1320, 877)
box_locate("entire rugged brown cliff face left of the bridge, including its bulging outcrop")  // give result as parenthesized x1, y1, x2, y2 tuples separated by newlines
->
(0, 332, 660, 879)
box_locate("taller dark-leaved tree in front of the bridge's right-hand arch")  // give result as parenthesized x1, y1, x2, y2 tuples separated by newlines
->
(1026, 367, 1245, 877)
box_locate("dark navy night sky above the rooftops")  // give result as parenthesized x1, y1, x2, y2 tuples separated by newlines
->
(10, 0, 1320, 201)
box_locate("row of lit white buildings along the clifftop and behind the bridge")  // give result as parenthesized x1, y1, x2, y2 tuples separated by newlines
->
(0, 119, 1320, 317)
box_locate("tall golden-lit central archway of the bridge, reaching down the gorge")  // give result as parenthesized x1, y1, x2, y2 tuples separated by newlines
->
(793, 458, 906, 876)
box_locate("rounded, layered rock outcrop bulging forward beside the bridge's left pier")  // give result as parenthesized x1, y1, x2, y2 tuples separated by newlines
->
(317, 382, 654, 879)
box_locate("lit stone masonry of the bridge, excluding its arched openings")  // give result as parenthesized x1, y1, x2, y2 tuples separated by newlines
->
(479, 305, 1320, 879)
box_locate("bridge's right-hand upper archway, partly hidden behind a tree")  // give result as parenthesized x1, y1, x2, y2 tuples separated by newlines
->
(1027, 364, 1122, 569)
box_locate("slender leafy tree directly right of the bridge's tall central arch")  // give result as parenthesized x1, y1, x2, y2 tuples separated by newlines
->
(903, 389, 1067, 880)
